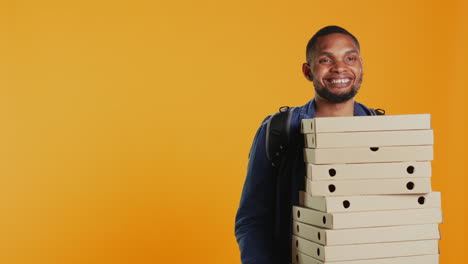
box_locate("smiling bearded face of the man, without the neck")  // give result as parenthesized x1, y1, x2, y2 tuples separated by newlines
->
(309, 33, 363, 103)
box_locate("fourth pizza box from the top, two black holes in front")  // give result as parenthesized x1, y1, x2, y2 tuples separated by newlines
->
(307, 161, 432, 181)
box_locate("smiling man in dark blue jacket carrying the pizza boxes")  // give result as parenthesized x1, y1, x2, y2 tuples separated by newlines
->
(235, 26, 375, 264)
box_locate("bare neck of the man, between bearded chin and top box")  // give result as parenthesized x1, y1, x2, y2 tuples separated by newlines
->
(315, 96, 354, 117)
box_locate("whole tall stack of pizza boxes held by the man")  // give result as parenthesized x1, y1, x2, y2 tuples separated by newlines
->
(292, 114, 442, 264)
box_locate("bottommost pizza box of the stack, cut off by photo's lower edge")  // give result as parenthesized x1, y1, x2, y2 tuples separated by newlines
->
(292, 252, 439, 264)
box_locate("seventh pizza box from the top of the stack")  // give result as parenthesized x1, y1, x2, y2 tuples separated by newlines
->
(293, 206, 442, 229)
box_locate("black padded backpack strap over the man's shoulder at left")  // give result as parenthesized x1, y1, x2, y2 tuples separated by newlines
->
(265, 106, 293, 166)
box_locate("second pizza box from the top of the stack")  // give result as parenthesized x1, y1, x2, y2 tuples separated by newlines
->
(304, 129, 434, 148)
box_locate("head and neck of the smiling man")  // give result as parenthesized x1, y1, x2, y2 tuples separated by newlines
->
(302, 27, 363, 117)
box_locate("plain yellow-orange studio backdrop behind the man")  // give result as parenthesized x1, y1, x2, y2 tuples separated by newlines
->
(0, 0, 468, 264)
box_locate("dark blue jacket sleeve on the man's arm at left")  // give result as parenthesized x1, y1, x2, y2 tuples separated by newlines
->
(235, 122, 275, 264)
